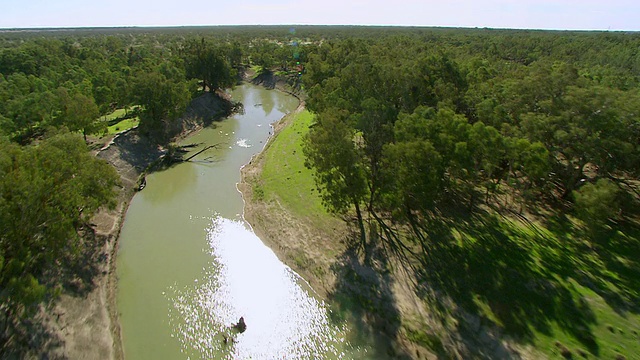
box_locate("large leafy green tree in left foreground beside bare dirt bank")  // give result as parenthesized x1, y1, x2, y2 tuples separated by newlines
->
(0, 133, 118, 315)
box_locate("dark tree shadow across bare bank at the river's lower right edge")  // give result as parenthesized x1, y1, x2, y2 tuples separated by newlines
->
(329, 238, 410, 359)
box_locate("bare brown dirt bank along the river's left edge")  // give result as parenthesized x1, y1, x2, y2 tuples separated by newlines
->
(26, 129, 164, 359)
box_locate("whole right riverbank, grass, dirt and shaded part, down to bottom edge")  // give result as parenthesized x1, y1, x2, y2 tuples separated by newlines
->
(237, 82, 556, 359)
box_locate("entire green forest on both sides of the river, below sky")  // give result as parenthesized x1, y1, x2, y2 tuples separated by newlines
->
(0, 26, 640, 357)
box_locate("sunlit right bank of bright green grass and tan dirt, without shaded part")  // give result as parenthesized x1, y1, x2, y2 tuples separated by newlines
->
(239, 107, 344, 282)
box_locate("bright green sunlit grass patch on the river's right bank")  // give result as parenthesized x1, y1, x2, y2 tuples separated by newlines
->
(259, 110, 334, 225)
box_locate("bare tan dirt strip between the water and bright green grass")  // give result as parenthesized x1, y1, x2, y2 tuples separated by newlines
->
(237, 69, 342, 300)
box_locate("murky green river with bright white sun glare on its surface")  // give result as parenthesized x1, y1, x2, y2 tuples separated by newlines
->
(117, 85, 367, 359)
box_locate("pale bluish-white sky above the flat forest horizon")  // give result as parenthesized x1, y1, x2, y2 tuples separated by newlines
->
(0, 0, 640, 31)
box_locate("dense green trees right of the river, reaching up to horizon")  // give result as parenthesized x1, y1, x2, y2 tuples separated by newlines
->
(304, 32, 640, 255)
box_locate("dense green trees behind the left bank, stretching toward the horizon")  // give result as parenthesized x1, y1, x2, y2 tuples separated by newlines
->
(0, 35, 238, 142)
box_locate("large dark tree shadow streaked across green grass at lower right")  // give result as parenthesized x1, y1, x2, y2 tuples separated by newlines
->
(418, 214, 599, 355)
